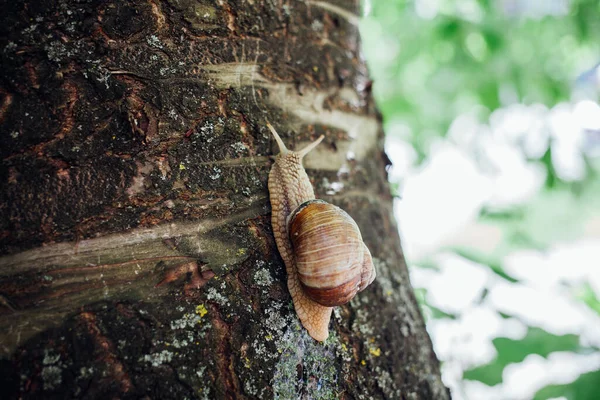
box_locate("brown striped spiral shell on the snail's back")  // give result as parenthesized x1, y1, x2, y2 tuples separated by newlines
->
(287, 200, 375, 307)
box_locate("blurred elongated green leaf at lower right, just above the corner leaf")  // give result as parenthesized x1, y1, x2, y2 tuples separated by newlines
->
(463, 327, 582, 386)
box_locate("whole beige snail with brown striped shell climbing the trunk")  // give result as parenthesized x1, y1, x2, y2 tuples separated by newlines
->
(267, 123, 375, 341)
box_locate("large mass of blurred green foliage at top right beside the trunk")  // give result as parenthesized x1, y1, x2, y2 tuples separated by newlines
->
(362, 0, 600, 152)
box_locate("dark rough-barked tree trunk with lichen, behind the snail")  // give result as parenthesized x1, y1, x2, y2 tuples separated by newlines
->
(0, 0, 449, 399)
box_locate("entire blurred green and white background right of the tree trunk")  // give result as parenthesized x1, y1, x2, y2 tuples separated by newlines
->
(361, 0, 600, 400)
